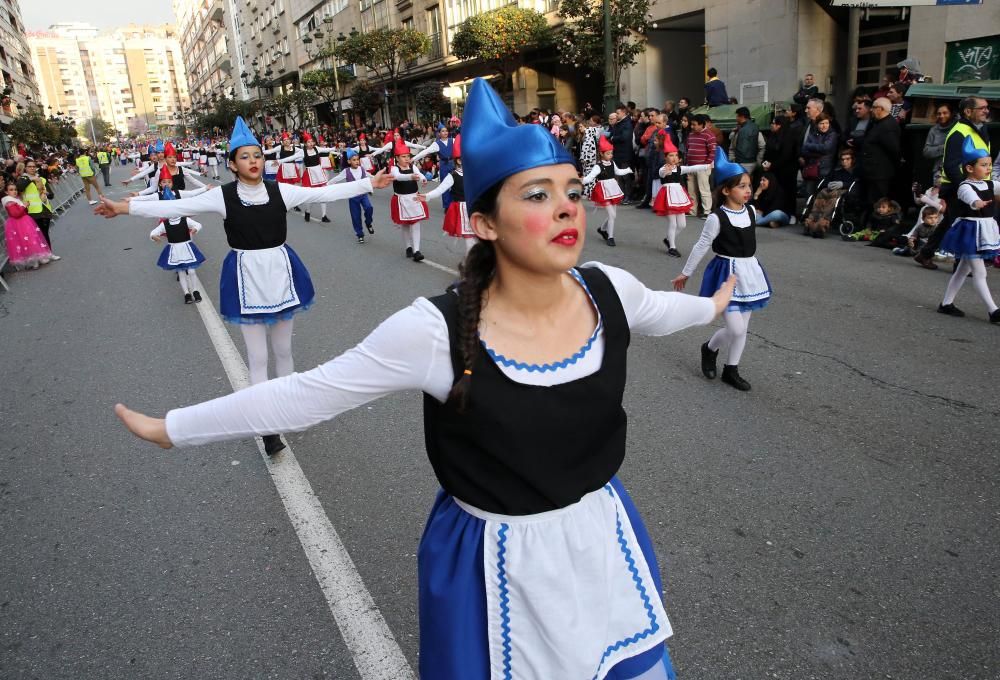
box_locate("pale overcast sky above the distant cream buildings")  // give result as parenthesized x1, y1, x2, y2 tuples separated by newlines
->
(20, 0, 175, 31)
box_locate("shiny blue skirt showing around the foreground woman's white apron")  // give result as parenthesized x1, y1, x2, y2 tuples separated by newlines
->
(417, 477, 676, 680)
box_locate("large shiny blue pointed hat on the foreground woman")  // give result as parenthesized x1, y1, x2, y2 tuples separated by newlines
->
(462, 78, 574, 206)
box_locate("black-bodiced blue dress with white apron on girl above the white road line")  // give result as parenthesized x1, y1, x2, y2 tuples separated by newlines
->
(219, 181, 315, 324)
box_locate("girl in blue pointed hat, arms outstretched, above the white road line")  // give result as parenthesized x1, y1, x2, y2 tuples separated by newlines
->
(95, 117, 389, 454)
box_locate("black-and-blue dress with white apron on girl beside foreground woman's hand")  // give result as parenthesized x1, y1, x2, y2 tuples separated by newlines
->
(698, 206, 771, 312)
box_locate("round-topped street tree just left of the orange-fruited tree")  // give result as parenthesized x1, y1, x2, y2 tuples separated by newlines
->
(333, 28, 431, 121)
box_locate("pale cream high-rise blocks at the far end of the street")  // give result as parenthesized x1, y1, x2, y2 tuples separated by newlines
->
(29, 23, 191, 134)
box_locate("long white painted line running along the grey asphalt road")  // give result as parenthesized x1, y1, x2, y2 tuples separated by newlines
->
(196, 292, 416, 680)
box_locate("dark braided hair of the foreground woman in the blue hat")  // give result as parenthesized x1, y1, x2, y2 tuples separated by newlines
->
(448, 181, 503, 413)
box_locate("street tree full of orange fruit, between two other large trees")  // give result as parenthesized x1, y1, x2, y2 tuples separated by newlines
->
(451, 6, 552, 94)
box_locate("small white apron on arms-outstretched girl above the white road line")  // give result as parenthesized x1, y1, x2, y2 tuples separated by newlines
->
(236, 245, 299, 314)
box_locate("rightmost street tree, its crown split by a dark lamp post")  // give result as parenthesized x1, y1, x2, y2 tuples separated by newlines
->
(556, 0, 651, 96)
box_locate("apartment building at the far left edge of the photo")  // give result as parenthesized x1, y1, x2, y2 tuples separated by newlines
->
(0, 0, 39, 124)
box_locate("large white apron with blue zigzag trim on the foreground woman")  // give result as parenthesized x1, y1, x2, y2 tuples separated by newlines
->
(466, 484, 673, 680)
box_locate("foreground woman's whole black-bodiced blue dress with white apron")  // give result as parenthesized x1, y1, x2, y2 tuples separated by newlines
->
(418, 268, 674, 680)
